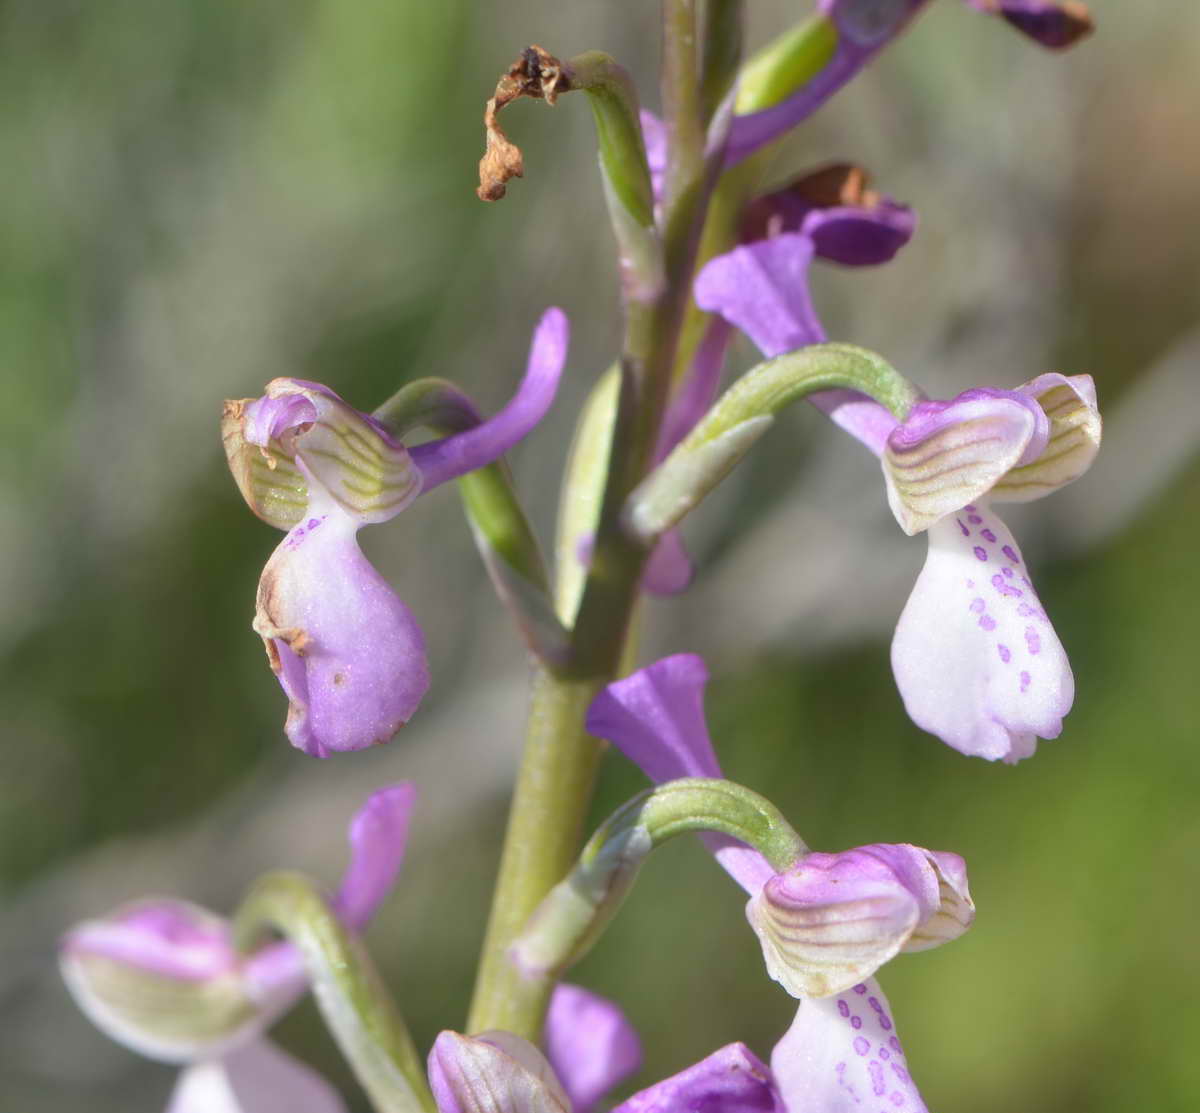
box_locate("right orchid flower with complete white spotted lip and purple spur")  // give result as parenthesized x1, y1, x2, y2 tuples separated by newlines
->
(696, 205, 1100, 762)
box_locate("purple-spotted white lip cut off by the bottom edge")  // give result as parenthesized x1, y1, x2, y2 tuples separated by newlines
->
(770, 977, 929, 1113)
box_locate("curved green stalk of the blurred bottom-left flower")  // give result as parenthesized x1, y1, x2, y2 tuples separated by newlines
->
(234, 872, 437, 1113)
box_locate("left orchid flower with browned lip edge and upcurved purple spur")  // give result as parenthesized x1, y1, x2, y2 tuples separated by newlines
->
(222, 309, 568, 757)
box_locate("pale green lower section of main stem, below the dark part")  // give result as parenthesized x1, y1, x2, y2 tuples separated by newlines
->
(467, 669, 602, 1043)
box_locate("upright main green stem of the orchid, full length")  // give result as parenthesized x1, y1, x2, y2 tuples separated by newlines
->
(468, 0, 729, 1042)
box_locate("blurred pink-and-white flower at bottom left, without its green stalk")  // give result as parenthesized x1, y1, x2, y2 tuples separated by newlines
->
(60, 783, 415, 1113)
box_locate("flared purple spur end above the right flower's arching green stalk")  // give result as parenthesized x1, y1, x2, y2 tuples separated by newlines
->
(694, 233, 826, 356)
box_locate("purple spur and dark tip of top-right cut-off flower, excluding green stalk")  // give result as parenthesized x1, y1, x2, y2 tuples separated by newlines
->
(726, 0, 1092, 166)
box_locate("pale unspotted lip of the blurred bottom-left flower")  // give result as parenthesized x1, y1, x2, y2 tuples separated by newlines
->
(167, 1040, 346, 1113)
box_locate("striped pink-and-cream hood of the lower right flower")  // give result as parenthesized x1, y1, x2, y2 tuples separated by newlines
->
(746, 843, 974, 997)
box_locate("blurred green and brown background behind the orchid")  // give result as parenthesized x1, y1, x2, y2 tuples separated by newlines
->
(0, 0, 1200, 1113)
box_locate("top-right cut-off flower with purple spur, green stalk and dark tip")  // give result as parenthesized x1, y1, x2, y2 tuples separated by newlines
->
(726, 0, 1092, 166)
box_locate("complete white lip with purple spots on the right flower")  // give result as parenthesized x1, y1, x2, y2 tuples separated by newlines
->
(892, 504, 1075, 762)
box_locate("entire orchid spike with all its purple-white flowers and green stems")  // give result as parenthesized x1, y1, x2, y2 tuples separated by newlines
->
(61, 0, 1100, 1113)
